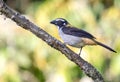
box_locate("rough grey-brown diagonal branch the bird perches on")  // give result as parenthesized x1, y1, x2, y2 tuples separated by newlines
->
(0, 0, 104, 82)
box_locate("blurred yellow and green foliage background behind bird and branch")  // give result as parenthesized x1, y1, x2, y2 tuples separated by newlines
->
(0, 0, 120, 82)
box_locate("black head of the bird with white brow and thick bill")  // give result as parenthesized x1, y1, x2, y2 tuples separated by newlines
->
(50, 18, 69, 27)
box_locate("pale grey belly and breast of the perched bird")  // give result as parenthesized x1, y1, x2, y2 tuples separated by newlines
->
(60, 34, 85, 48)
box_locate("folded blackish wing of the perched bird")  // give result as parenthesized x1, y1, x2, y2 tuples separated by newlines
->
(62, 26, 95, 39)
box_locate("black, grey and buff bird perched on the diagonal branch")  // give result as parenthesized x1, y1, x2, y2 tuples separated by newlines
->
(50, 18, 117, 55)
